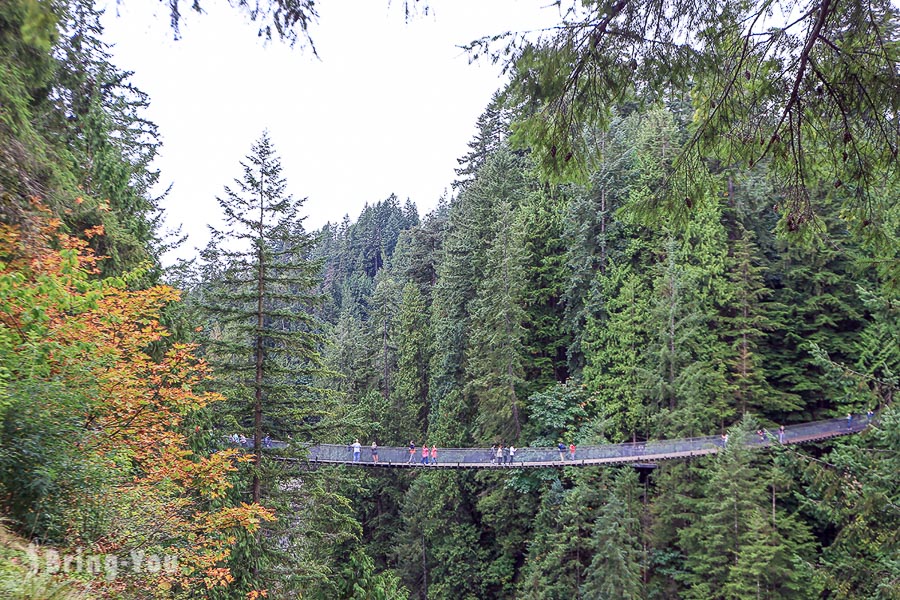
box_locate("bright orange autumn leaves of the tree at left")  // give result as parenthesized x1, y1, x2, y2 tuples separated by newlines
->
(0, 222, 274, 589)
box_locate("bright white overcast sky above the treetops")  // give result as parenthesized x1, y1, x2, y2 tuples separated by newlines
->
(98, 0, 559, 261)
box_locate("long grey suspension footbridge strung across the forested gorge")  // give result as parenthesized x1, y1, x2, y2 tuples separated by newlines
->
(268, 415, 870, 469)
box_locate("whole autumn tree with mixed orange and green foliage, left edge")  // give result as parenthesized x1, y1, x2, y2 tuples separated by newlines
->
(0, 211, 273, 595)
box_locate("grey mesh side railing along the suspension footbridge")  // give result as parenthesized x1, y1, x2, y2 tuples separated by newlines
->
(255, 415, 869, 465)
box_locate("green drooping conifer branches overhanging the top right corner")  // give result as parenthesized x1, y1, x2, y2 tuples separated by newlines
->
(468, 0, 900, 240)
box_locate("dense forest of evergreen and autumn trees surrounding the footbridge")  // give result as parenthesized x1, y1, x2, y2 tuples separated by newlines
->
(0, 0, 900, 600)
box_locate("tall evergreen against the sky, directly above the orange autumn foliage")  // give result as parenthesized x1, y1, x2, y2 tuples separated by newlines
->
(49, 0, 164, 283)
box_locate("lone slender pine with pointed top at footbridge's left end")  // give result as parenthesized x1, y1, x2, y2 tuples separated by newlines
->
(204, 132, 352, 593)
